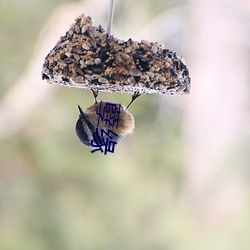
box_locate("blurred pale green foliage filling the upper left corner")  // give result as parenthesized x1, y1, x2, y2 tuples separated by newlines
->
(0, 0, 70, 97)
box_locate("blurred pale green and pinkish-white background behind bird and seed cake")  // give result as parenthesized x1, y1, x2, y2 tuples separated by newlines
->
(0, 0, 250, 250)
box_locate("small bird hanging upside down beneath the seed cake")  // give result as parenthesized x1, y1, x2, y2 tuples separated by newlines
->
(75, 89, 135, 149)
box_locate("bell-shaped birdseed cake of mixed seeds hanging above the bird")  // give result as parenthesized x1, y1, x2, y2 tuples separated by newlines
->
(42, 15, 190, 94)
